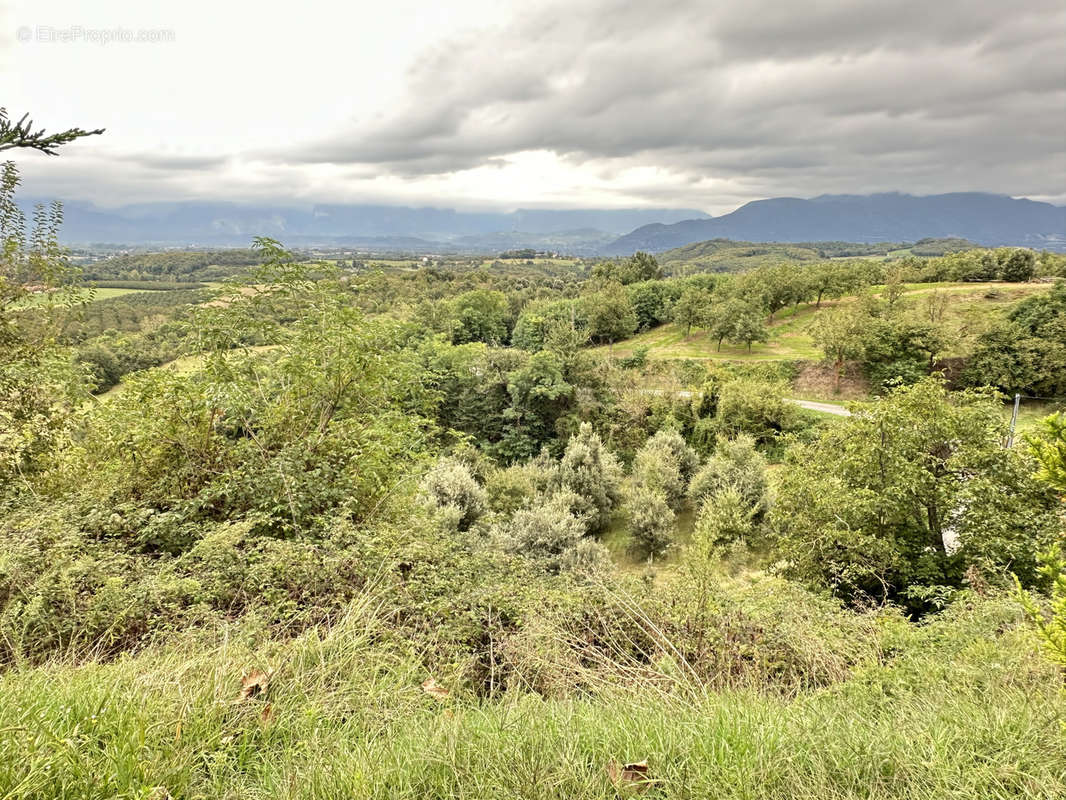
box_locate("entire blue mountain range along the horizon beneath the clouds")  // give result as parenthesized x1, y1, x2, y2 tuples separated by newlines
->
(25, 192, 1066, 255)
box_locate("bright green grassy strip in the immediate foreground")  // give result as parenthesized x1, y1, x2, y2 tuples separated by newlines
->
(0, 584, 1066, 800)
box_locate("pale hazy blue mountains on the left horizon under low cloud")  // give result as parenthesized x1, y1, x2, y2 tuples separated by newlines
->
(29, 202, 706, 252)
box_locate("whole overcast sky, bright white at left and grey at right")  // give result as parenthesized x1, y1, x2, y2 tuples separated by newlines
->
(0, 0, 1066, 213)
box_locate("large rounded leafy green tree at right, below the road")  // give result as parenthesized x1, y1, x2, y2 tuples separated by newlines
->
(772, 378, 1059, 613)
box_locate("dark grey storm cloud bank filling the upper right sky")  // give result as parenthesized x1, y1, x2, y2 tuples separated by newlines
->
(276, 0, 1066, 195)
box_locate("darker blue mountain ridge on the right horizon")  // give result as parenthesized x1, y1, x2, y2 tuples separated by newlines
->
(603, 192, 1066, 255)
